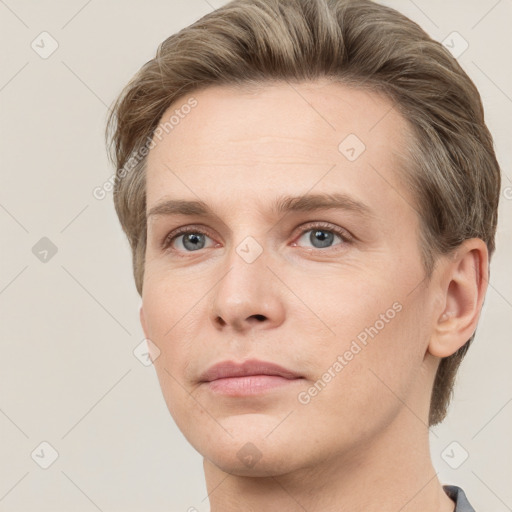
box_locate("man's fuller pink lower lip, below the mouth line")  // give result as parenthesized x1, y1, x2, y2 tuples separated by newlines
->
(205, 375, 302, 396)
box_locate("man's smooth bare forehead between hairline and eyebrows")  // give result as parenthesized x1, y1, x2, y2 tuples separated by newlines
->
(147, 80, 409, 216)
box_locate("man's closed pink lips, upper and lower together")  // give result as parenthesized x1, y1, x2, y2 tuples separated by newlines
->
(200, 359, 303, 396)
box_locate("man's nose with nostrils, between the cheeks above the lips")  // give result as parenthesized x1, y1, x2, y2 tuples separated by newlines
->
(210, 243, 285, 333)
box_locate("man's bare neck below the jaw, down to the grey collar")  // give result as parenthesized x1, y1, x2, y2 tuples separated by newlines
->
(204, 408, 454, 512)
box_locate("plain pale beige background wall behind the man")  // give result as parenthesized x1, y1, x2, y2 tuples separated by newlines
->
(0, 0, 512, 512)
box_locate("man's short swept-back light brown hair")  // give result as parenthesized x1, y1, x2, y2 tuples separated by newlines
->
(107, 0, 500, 425)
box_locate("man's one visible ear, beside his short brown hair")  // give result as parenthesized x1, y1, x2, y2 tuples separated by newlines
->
(428, 238, 489, 357)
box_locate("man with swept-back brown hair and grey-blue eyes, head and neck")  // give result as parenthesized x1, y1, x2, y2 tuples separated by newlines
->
(105, 0, 500, 512)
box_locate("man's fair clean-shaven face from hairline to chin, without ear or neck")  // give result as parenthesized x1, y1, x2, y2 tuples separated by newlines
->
(141, 81, 440, 475)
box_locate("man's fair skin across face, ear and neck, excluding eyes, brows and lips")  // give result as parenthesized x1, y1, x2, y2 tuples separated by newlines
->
(140, 81, 487, 512)
